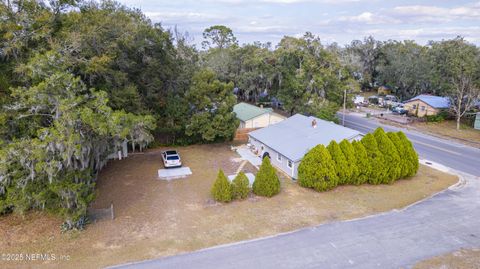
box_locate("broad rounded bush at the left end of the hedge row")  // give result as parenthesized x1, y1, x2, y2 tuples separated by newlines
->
(298, 145, 338, 191)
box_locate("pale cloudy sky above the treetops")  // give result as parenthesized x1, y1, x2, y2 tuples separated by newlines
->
(120, 0, 480, 45)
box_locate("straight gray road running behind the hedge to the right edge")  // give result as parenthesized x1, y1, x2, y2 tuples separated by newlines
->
(345, 112, 480, 176)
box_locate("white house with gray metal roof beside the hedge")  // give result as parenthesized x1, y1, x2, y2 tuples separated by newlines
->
(248, 114, 363, 179)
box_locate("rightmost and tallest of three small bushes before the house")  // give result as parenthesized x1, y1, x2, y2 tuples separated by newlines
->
(252, 157, 280, 197)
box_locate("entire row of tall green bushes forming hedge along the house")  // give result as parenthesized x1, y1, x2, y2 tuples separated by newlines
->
(298, 128, 419, 191)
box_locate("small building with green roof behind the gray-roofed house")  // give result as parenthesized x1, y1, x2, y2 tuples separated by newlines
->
(233, 103, 285, 129)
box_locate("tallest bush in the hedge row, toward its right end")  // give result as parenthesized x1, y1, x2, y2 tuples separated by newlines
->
(373, 127, 402, 184)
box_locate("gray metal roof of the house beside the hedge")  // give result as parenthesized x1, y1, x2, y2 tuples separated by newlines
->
(248, 114, 362, 162)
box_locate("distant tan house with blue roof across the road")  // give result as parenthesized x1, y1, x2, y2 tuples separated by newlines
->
(404, 94, 450, 117)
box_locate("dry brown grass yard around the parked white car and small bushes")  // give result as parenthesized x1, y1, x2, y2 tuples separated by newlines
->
(0, 144, 458, 268)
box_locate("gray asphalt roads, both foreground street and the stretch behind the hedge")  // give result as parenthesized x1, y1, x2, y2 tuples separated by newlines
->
(109, 113, 480, 269)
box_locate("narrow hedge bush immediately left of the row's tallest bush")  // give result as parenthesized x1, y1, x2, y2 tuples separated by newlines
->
(361, 134, 388, 184)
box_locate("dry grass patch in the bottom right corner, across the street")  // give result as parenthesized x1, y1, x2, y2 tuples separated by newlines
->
(413, 249, 480, 269)
